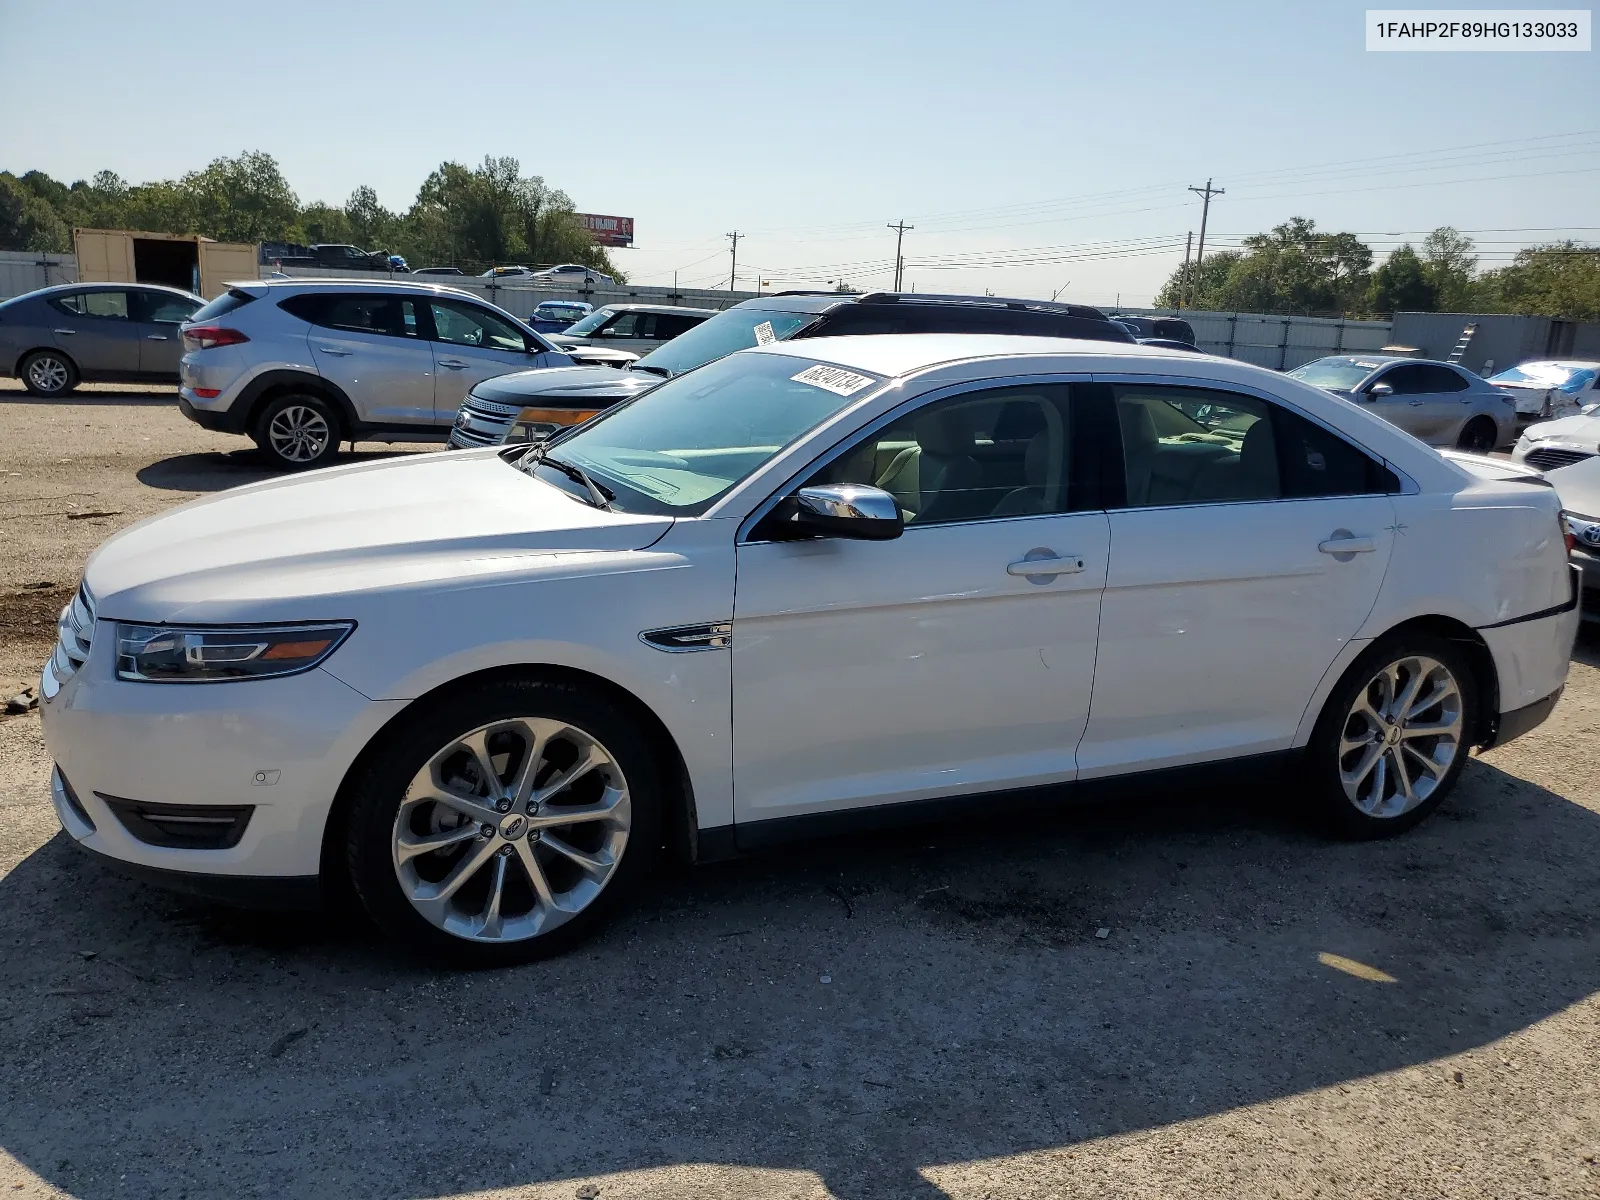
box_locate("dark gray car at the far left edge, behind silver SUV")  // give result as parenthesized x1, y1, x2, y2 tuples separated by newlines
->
(0, 283, 205, 397)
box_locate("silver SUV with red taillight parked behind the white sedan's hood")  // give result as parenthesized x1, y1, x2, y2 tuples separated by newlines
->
(178, 280, 576, 467)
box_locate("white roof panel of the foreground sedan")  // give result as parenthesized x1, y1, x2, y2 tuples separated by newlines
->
(742, 333, 1222, 379)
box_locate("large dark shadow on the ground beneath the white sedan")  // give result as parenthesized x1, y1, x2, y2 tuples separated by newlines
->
(0, 760, 1600, 1200)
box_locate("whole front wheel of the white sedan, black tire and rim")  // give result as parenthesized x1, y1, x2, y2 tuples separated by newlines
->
(346, 678, 662, 966)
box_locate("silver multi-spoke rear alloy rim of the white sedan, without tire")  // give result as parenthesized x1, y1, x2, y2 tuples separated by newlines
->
(1339, 654, 1464, 818)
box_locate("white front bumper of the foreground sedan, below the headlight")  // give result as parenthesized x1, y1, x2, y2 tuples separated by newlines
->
(40, 621, 403, 893)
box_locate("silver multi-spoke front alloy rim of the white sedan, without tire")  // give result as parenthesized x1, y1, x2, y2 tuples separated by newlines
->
(394, 717, 632, 942)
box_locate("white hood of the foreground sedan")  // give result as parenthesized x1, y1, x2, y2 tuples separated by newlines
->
(85, 450, 672, 622)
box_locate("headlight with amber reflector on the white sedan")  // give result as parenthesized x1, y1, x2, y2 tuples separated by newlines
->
(117, 621, 355, 683)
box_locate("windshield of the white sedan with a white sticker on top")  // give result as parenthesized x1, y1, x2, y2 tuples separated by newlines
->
(515, 354, 880, 517)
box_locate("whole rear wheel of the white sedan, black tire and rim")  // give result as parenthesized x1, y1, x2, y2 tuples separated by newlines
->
(1306, 632, 1478, 840)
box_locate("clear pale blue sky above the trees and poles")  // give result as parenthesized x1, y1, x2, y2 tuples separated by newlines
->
(0, 0, 1600, 304)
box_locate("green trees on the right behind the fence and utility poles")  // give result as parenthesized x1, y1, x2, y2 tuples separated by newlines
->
(1155, 216, 1600, 320)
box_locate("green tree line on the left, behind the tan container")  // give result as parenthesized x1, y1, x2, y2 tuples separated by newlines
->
(0, 150, 622, 282)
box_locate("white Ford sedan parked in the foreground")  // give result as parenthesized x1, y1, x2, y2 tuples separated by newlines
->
(34, 336, 1578, 963)
